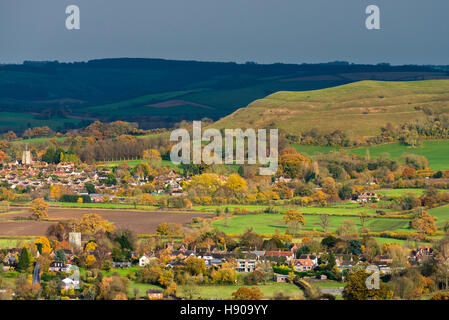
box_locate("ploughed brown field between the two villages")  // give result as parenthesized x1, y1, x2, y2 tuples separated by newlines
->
(0, 208, 210, 236)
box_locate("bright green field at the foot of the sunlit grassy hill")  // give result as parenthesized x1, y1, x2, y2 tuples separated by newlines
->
(294, 140, 449, 170)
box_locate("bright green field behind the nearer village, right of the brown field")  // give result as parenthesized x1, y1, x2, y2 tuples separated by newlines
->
(213, 213, 413, 234)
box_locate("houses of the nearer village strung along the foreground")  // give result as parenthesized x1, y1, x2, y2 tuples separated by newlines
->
(0, 240, 433, 299)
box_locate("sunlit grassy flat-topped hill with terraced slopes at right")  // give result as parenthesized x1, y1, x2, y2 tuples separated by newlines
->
(214, 80, 449, 137)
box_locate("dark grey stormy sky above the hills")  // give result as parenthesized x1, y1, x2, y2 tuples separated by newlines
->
(0, 0, 449, 65)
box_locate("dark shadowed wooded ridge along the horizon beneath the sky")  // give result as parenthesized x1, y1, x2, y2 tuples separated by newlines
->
(0, 58, 449, 131)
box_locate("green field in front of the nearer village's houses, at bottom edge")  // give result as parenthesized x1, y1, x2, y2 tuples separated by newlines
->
(177, 283, 303, 300)
